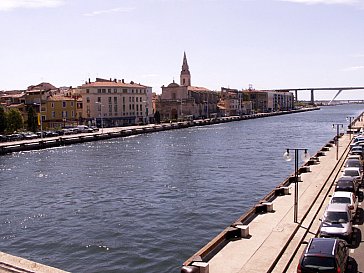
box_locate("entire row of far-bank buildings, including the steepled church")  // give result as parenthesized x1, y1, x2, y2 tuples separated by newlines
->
(0, 53, 294, 129)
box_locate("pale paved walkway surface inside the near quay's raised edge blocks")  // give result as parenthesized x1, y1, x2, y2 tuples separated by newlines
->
(208, 131, 350, 273)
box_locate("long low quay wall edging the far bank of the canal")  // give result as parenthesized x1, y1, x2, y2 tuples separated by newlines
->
(0, 107, 320, 155)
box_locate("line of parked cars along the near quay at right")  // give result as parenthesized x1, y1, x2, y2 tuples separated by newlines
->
(297, 135, 364, 273)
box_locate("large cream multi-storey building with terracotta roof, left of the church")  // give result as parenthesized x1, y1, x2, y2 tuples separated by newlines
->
(80, 78, 153, 127)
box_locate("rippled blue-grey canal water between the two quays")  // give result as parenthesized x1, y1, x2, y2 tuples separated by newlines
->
(0, 105, 364, 273)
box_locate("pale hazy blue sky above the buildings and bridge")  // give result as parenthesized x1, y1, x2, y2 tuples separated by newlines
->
(0, 0, 364, 99)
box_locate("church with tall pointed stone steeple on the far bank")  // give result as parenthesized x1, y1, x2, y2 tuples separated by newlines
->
(154, 53, 218, 120)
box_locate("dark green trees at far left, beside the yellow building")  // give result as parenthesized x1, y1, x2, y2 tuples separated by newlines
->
(0, 106, 38, 134)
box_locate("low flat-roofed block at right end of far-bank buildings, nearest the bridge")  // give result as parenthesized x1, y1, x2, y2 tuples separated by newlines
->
(243, 88, 294, 113)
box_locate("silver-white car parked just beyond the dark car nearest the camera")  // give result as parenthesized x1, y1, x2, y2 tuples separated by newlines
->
(319, 203, 353, 242)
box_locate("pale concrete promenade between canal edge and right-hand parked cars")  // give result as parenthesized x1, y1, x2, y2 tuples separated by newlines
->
(181, 117, 363, 273)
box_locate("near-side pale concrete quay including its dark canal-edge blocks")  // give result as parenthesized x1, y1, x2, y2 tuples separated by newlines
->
(181, 110, 364, 273)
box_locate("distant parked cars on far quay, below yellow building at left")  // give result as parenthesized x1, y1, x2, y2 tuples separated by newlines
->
(0, 125, 99, 142)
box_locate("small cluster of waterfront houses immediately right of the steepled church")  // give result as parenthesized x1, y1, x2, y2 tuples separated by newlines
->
(217, 87, 252, 116)
